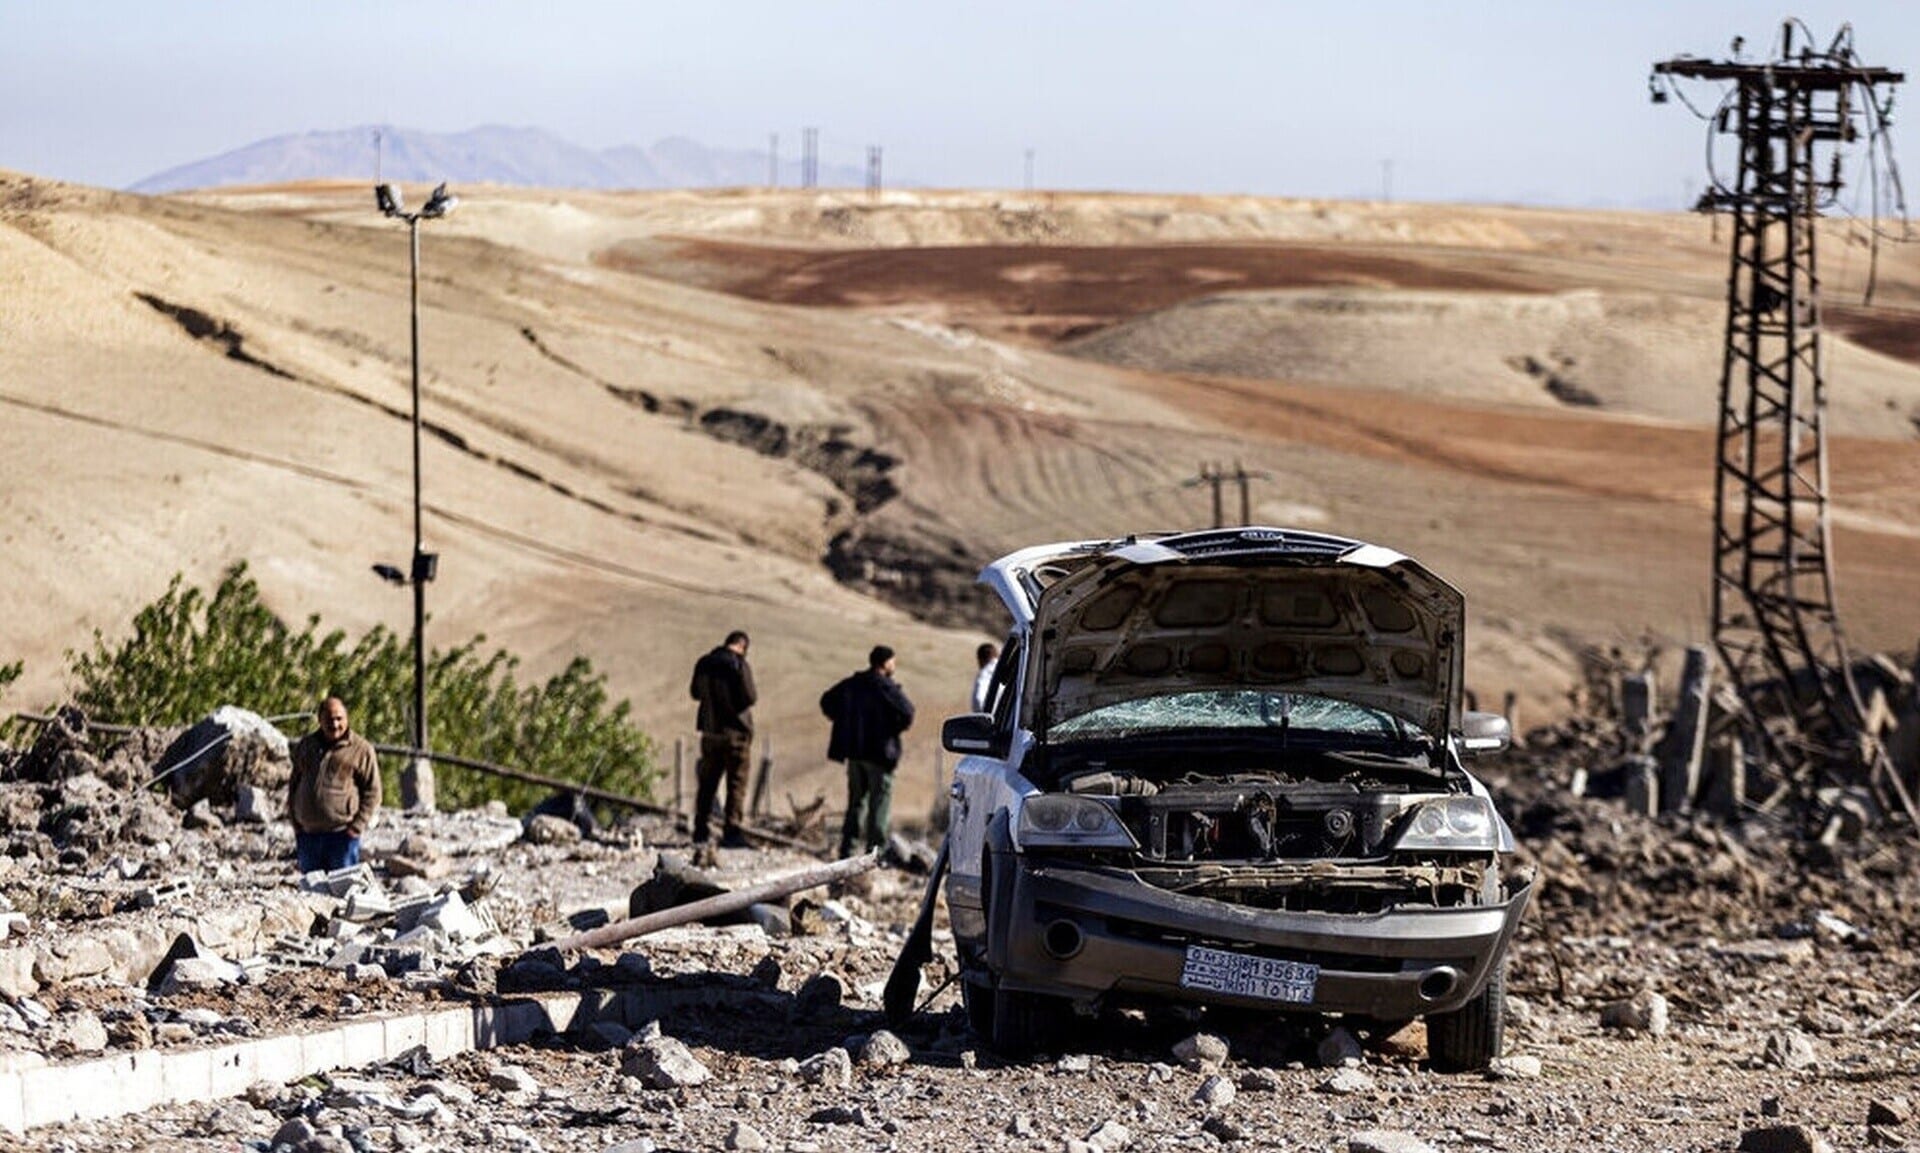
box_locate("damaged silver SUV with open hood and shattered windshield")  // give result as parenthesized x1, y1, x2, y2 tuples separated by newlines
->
(929, 528, 1530, 1071)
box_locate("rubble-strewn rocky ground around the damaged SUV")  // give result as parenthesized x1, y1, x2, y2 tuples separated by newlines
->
(0, 705, 1920, 1151)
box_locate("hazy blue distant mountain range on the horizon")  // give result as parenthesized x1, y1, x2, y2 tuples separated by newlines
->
(131, 125, 866, 192)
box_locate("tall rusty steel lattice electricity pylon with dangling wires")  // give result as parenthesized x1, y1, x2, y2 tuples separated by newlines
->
(1653, 23, 1907, 804)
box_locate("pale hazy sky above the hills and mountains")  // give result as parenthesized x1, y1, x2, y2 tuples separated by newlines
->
(0, 0, 1920, 207)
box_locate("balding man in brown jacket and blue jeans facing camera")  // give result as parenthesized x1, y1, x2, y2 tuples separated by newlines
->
(286, 696, 380, 873)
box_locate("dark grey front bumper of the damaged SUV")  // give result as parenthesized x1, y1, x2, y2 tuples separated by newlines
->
(987, 858, 1532, 1021)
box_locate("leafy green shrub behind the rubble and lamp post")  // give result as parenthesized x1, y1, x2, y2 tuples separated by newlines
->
(63, 564, 659, 812)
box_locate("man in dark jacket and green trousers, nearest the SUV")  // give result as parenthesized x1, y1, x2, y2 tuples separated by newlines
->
(820, 645, 914, 858)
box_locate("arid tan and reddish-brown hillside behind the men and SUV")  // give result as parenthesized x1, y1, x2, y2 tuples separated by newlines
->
(0, 175, 1920, 804)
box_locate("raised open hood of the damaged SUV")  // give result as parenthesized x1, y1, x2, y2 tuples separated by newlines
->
(1013, 528, 1467, 742)
